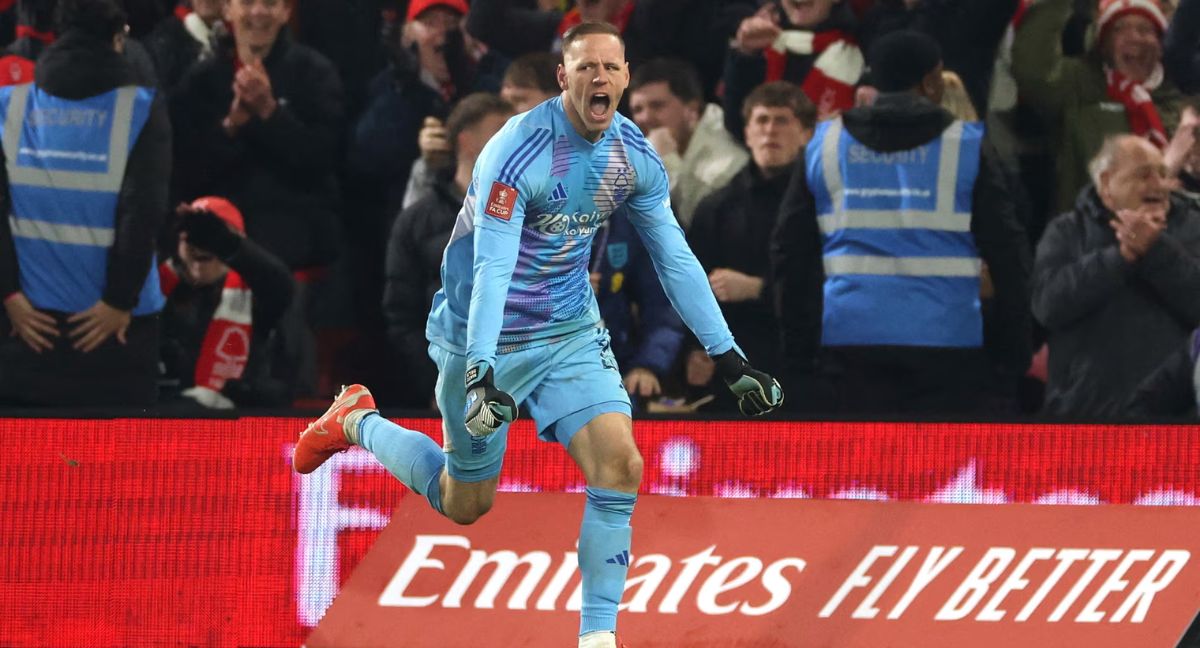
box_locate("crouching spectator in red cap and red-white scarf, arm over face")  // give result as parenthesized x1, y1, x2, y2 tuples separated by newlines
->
(158, 197, 293, 409)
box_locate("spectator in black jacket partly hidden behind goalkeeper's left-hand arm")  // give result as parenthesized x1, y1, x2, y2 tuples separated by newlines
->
(383, 92, 512, 407)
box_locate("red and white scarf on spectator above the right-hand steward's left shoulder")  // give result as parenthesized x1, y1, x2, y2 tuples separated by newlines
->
(763, 29, 865, 118)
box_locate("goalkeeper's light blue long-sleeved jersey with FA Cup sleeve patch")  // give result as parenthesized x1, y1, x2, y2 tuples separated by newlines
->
(426, 97, 733, 366)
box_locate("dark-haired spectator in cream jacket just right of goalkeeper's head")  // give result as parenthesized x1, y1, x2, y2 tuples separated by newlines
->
(629, 59, 749, 230)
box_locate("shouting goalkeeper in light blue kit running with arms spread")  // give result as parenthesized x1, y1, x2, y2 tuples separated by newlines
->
(293, 23, 784, 647)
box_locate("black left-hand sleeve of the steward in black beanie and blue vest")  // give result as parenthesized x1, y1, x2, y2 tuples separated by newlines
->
(770, 156, 824, 373)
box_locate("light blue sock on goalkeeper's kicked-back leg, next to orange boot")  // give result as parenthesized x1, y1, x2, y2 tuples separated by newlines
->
(359, 412, 446, 515)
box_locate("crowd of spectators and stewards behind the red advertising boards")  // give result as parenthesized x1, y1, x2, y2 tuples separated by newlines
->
(0, 0, 1200, 420)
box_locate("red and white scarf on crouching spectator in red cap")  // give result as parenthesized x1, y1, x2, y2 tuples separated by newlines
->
(158, 259, 251, 407)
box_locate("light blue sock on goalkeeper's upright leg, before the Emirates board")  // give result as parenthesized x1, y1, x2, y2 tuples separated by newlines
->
(580, 487, 637, 635)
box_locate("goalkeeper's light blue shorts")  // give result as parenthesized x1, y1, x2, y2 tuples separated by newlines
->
(430, 328, 632, 481)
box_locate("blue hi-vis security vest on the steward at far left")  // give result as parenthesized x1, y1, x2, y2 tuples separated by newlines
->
(0, 84, 163, 316)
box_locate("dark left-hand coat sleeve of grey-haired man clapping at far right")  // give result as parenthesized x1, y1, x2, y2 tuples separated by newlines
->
(1033, 214, 1130, 330)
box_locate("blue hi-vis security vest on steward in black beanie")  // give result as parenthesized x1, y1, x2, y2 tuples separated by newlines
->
(805, 119, 983, 347)
